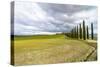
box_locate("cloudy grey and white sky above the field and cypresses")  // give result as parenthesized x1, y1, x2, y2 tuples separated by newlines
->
(14, 2, 97, 35)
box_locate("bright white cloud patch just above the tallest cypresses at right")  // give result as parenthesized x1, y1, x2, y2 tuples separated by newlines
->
(73, 9, 97, 22)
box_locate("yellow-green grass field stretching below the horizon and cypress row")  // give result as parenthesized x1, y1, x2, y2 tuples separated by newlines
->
(12, 35, 97, 65)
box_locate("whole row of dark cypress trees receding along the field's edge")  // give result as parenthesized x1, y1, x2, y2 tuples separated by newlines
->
(65, 20, 94, 40)
